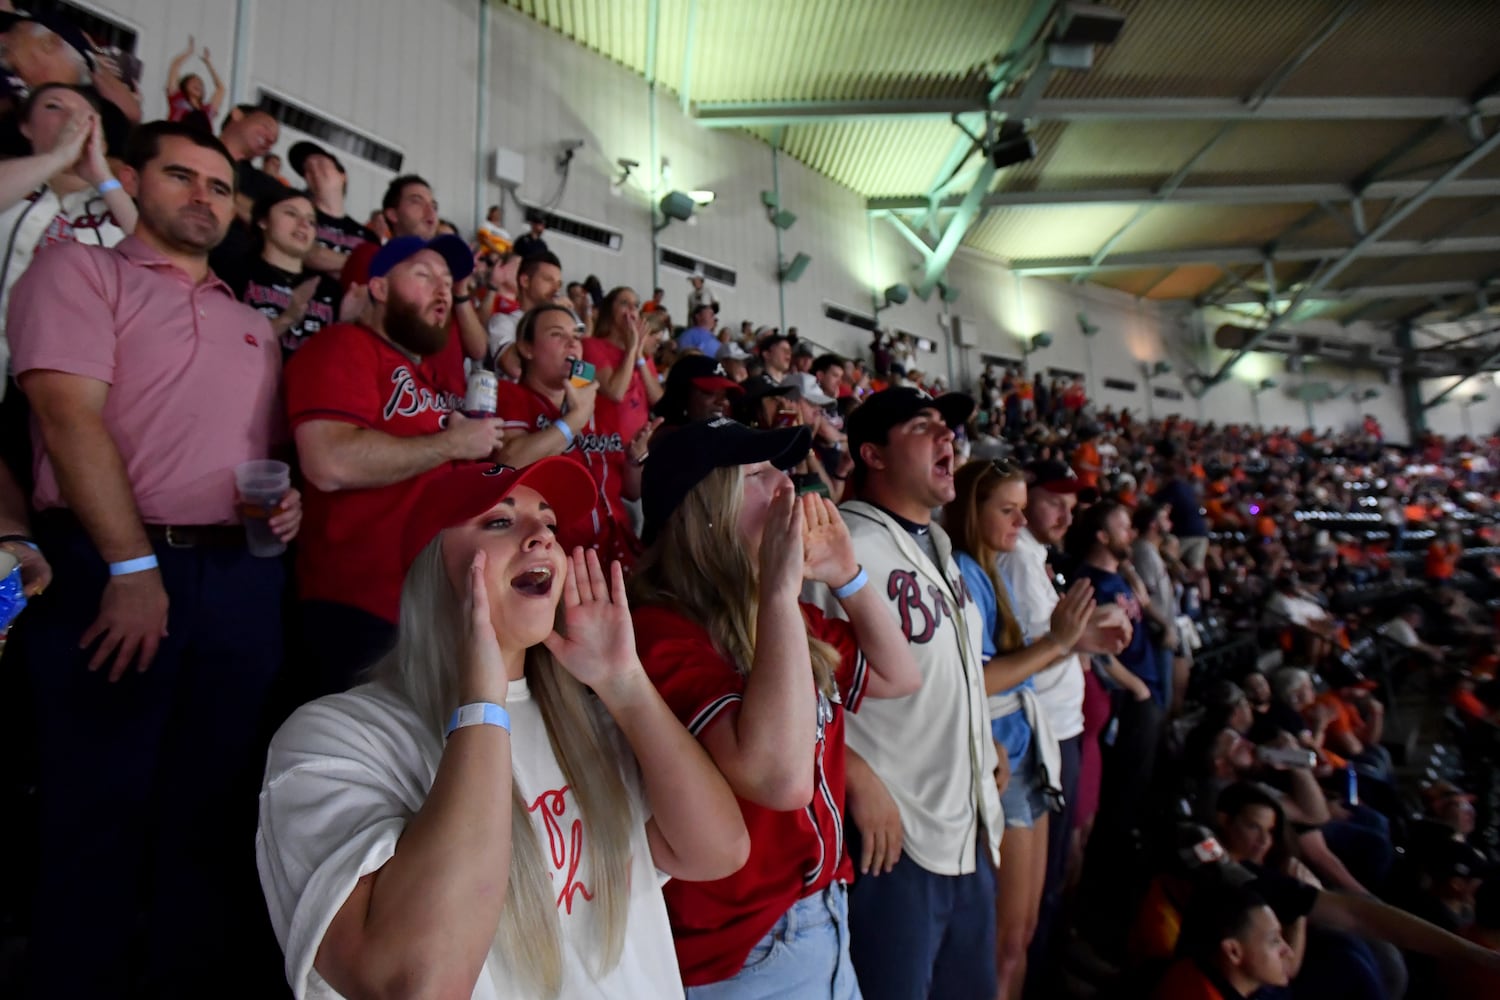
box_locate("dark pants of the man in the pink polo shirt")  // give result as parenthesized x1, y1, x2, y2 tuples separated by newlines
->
(24, 516, 284, 999)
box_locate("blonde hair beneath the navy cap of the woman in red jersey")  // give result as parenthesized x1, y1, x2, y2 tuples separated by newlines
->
(630, 466, 839, 697)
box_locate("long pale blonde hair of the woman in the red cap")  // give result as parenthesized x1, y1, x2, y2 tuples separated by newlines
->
(371, 540, 633, 997)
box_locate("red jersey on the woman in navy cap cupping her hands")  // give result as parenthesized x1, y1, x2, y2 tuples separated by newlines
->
(632, 604, 867, 987)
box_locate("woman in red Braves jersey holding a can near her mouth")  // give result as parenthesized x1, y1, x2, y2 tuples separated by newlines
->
(495, 303, 660, 570)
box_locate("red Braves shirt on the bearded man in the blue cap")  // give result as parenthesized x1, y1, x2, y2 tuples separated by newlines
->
(285, 322, 464, 622)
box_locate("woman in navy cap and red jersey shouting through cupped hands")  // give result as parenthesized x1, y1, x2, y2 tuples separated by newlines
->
(632, 420, 921, 1000)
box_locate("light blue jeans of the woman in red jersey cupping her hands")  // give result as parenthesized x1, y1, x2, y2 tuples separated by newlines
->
(687, 883, 861, 1000)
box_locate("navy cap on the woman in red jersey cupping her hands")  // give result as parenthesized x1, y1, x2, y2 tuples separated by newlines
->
(641, 417, 813, 544)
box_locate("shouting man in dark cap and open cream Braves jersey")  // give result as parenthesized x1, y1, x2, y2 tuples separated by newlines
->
(824, 388, 1004, 1000)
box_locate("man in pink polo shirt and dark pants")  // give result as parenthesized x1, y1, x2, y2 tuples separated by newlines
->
(8, 121, 302, 997)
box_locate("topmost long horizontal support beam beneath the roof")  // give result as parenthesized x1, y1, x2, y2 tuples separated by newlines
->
(693, 97, 1500, 129)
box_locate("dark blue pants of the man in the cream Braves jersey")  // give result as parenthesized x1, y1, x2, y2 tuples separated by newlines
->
(845, 822, 998, 1000)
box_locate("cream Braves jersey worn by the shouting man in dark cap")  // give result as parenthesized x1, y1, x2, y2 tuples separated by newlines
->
(816, 501, 1005, 876)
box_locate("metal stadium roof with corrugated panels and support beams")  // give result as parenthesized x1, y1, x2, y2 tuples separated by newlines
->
(506, 0, 1500, 370)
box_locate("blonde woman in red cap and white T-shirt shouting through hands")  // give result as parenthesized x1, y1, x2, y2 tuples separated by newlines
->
(257, 459, 749, 1000)
